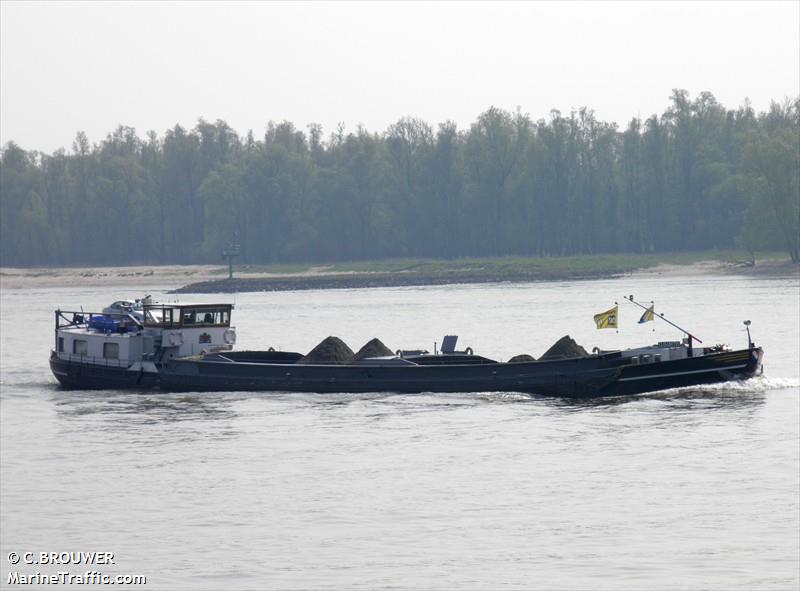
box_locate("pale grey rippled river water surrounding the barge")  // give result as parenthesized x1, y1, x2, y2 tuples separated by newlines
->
(0, 275, 800, 590)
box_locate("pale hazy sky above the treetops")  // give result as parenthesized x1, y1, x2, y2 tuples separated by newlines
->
(0, 0, 800, 152)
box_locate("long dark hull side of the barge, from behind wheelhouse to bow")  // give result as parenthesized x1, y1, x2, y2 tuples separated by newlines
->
(159, 348, 763, 398)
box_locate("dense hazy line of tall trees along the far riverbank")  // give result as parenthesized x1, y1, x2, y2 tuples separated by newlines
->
(0, 90, 800, 266)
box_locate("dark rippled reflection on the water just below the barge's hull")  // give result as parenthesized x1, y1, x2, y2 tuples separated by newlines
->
(45, 381, 780, 426)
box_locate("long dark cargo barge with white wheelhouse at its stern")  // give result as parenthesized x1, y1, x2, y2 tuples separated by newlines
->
(50, 298, 764, 398)
